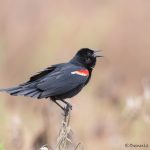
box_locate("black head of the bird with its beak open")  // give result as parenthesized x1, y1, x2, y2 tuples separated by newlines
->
(71, 48, 103, 69)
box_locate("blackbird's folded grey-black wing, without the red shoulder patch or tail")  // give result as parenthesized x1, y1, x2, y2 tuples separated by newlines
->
(36, 64, 88, 98)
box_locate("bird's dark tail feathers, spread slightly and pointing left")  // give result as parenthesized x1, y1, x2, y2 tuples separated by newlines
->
(0, 86, 41, 98)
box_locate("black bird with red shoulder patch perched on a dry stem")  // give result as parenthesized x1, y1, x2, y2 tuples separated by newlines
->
(0, 48, 102, 110)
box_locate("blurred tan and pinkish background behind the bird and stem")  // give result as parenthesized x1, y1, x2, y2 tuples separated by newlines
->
(0, 0, 150, 150)
